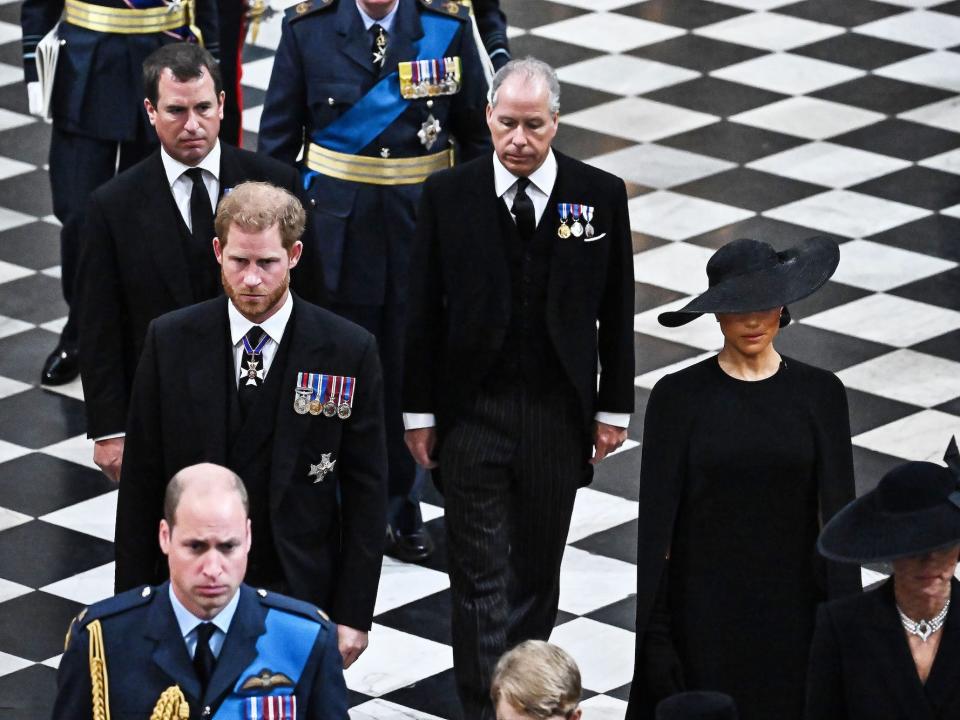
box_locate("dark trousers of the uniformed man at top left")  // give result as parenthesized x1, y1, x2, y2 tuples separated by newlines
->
(50, 123, 156, 348)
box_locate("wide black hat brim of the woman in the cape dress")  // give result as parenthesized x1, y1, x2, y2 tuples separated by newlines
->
(657, 235, 840, 327)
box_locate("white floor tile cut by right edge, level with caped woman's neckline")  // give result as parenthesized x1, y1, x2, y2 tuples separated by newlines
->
(837, 350, 960, 407)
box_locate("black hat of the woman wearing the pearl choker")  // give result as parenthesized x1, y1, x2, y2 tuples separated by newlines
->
(817, 438, 960, 565)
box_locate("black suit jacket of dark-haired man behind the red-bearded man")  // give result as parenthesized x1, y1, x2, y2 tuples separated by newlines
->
(78, 143, 323, 438)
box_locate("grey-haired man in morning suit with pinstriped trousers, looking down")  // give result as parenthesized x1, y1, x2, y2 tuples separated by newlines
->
(404, 58, 634, 720)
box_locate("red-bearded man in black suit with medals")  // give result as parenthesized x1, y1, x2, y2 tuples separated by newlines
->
(115, 182, 386, 666)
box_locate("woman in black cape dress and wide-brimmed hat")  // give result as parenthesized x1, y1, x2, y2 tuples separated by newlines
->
(627, 238, 859, 720)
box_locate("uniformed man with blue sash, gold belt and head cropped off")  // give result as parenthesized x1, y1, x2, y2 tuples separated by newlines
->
(258, 0, 491, 560)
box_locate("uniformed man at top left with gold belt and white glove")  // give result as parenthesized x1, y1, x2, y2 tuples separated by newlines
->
(20, 0, 217, 385)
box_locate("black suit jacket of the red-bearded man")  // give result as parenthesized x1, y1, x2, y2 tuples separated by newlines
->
(116, 297, 386, 629)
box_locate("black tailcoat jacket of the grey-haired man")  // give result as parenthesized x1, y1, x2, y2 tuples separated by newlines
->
(403, 151, 634, 433)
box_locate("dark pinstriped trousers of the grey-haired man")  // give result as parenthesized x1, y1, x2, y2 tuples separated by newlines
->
(440, 387, 585, 720)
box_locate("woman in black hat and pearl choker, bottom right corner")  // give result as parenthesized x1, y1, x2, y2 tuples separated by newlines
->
(806, 440, 960, 720)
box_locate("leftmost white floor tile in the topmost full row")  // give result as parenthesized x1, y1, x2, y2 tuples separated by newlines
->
(530, 12, 686, 53)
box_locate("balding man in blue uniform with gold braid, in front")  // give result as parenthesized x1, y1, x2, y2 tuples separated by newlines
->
(53, 464, 347, 720)
